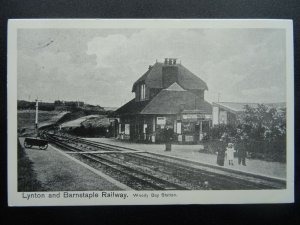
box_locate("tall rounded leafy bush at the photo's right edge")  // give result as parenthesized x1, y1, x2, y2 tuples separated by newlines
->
(237, 104, 286, 159)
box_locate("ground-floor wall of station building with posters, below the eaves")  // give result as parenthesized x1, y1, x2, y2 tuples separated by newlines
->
(116, 115, 212, 143)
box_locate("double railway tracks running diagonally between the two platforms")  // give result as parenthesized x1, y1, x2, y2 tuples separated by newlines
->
(44, 135, 286, 190)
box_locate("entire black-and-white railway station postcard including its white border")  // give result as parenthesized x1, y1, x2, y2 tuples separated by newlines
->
(7, 19, 294, 206)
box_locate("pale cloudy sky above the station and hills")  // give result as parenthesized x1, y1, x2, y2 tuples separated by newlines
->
(17, 29, 286, 107)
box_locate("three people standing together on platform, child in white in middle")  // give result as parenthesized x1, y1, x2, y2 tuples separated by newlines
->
(217, 133, 247, 166)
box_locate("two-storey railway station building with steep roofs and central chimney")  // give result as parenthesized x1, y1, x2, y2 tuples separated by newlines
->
(112, 58, 212, 143)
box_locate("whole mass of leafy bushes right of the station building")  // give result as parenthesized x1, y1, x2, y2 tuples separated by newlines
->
(204, 104, 286, 162)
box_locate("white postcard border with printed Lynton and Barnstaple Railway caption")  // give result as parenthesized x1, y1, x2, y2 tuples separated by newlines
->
(7, 19, 294, 206)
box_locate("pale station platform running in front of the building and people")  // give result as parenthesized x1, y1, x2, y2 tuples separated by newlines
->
(86, 138, 286, 179)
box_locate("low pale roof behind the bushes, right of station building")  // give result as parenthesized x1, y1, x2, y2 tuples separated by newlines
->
(213, 102, 286, 113)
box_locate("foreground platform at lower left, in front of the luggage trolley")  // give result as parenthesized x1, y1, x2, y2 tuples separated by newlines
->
(19, 138, 127, 191)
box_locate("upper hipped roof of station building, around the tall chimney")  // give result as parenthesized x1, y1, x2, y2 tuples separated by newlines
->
(132, 62, 208, 92)
